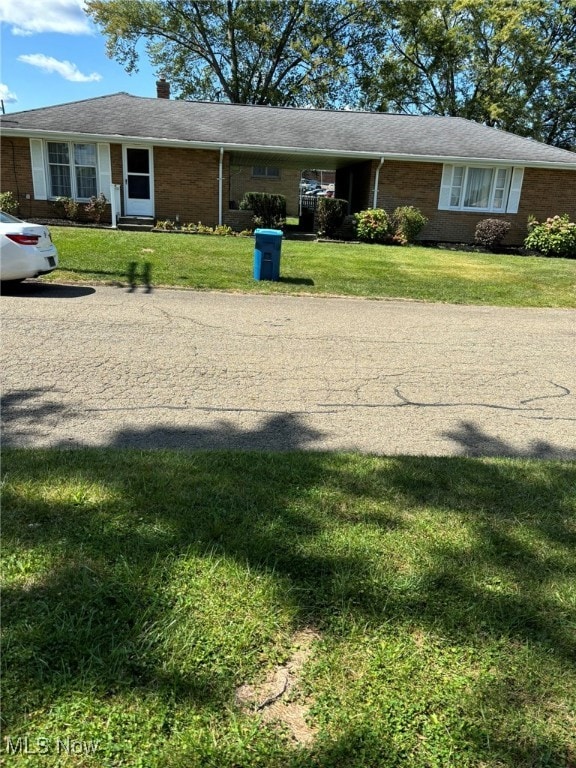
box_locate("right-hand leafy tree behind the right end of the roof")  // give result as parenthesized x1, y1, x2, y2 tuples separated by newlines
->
(356, 0, 576, 148)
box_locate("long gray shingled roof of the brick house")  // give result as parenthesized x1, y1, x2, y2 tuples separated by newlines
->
(0, 93, 576, 169)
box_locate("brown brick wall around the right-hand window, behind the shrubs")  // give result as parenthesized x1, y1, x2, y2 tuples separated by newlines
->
(370, 160, 576, 245)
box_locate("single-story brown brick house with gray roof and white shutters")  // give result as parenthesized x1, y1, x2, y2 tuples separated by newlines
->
(0, 81, 576, 244)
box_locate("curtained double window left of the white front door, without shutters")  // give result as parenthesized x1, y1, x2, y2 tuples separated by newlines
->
(47, 141, 97, 200)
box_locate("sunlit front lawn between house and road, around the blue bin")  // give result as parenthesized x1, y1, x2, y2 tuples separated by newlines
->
(46, 227, 576, 308)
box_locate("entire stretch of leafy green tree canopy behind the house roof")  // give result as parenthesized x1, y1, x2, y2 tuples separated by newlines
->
(86, 0, 576, 149)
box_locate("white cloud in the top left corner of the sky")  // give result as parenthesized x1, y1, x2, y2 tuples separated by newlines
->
(0, 0, 93, 35)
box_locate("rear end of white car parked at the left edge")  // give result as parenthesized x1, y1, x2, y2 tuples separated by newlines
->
(0, 211, 58, 281)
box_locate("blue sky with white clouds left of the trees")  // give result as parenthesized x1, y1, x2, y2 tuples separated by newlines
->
(0, 0, 157, 112)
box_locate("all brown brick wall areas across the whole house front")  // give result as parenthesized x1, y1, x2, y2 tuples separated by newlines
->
(0, 137, 576, 245)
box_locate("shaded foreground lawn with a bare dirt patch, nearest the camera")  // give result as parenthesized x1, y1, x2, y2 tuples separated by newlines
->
(0, 450, 576, 768)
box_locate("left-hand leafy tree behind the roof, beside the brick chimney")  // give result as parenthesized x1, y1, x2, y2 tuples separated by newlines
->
(86, 0, 359, 107)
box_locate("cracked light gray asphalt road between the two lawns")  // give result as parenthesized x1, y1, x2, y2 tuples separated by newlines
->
(0, 283, 576, 458)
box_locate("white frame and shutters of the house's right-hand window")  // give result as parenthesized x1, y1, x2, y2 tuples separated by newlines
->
(438, 163, 524, 213)
